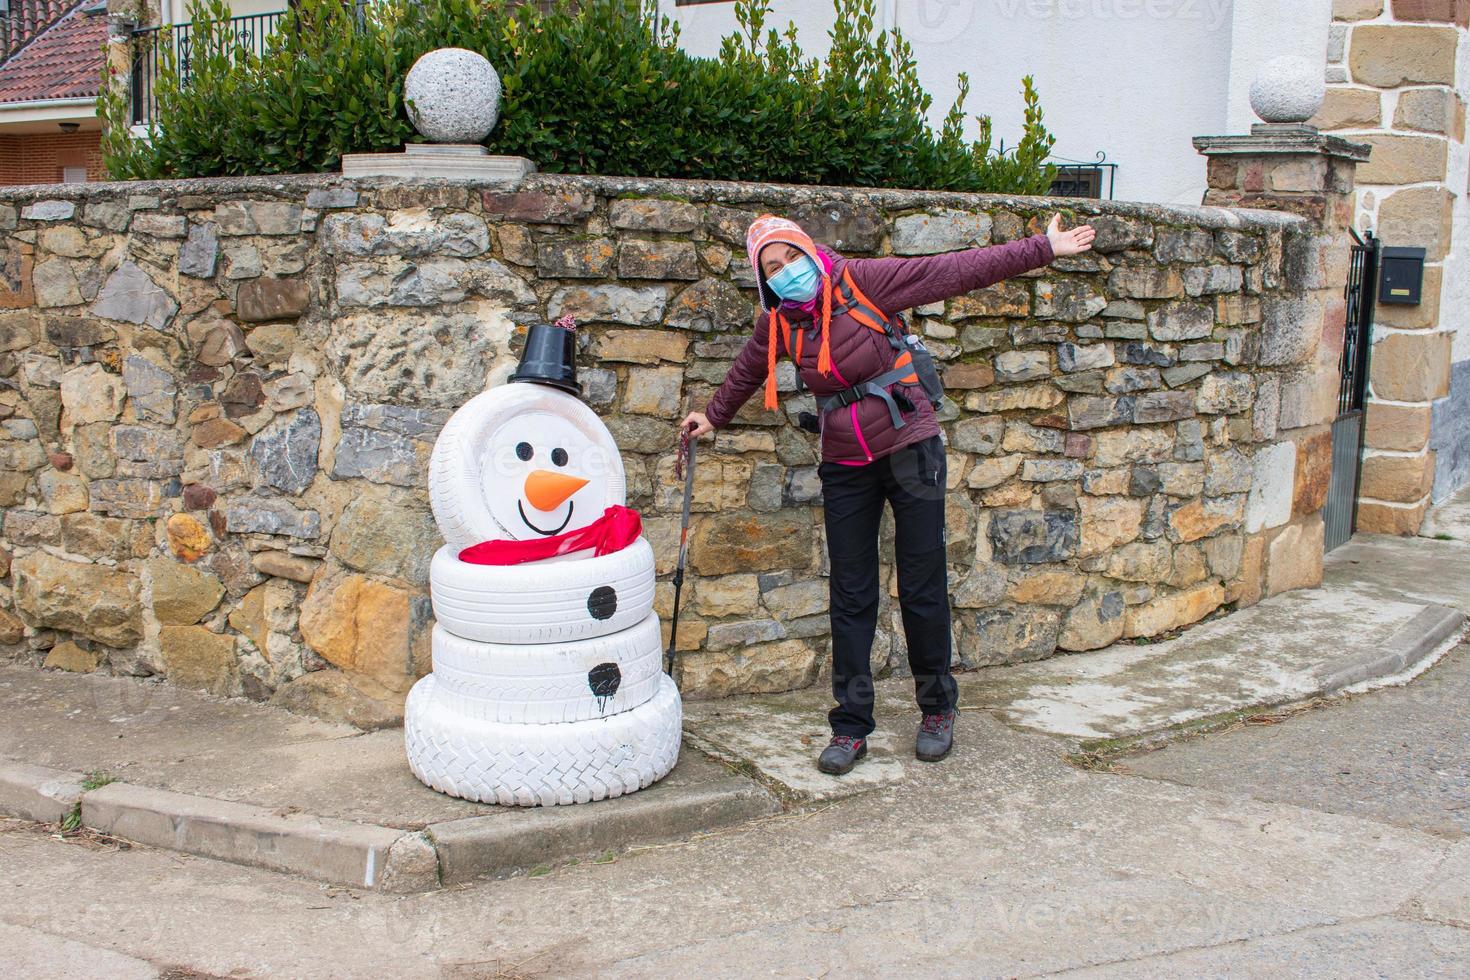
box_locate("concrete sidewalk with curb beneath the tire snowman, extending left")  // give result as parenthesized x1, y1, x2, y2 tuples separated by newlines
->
(0, 667, 781, 892)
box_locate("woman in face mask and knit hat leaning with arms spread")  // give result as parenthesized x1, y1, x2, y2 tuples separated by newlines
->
(682, 215, 1095, 774)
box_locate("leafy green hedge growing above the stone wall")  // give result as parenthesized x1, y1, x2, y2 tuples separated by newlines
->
(101, 0, 1054, 194)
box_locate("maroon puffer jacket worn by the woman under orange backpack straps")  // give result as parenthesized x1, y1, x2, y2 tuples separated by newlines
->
(704, 235, 1054, 464)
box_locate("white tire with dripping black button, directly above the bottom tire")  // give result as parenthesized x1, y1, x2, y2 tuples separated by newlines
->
(431, 613, 663, 724)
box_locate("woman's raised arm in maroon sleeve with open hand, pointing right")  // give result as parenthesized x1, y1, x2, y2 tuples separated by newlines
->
(850, 216, 1095, 313)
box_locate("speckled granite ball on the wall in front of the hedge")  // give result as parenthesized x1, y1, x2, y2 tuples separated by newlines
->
(403, 47, 500, 143)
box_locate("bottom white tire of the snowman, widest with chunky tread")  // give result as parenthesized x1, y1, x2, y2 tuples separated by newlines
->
(403, 674, 684, 807)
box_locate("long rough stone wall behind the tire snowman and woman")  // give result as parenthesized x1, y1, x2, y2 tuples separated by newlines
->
(0, 168, 1341, 724)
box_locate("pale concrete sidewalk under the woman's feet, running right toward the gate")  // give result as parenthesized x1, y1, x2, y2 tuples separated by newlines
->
(685, 491, 1470, 802)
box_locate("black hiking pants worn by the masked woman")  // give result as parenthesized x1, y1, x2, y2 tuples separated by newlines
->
(817, 436, 957, 738)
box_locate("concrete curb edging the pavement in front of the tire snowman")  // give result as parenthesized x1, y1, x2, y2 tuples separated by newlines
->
(0, 746, 781, 893)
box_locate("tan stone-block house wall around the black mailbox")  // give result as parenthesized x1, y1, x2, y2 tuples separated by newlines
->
(1313, 0, 1470, 533)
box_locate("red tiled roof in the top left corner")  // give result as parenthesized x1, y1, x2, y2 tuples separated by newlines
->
(0, 0, 107, 103)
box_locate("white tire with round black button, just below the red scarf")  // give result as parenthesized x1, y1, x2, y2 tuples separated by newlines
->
(429, 538, 654, 644)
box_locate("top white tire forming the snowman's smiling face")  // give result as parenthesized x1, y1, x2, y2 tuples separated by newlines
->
(429, 382, 628, 554)
